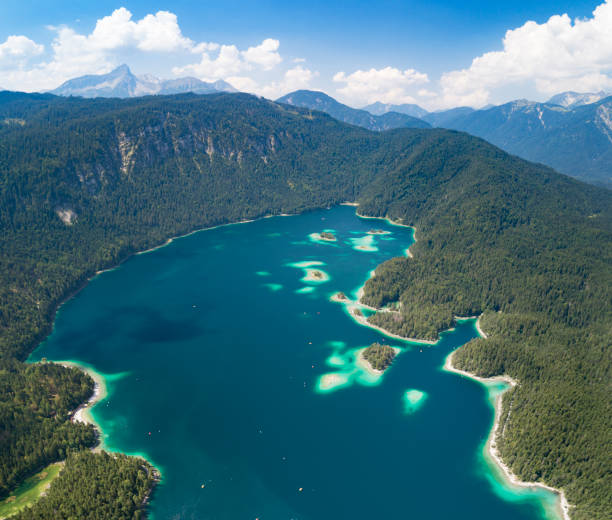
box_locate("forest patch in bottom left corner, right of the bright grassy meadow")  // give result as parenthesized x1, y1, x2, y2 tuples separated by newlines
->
(12, 451, 157, 520)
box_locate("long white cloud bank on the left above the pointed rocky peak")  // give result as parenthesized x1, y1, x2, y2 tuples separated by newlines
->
(0, 7, 282, 90)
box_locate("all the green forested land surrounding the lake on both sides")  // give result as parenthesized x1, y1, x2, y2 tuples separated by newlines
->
(0, 92, 612, 520)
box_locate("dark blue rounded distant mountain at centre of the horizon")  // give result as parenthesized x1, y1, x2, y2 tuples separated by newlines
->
(276, 90, 431, 131)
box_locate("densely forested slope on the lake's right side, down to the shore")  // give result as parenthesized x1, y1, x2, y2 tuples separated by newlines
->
(359, 129, 612, 519)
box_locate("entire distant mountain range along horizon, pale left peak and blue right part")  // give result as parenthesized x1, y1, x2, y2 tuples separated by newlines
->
(40, 65, 612, 188)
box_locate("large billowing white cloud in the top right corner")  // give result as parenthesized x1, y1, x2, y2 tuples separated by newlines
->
(440, 0, 612, 107)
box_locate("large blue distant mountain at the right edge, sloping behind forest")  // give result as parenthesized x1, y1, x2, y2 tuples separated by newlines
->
(425, 97, 612, 188)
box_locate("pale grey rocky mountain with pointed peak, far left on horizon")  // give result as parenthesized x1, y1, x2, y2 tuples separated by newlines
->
(50, 65, 236, 98)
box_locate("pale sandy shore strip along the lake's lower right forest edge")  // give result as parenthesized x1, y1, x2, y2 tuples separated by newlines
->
(444, 351, 570, 520)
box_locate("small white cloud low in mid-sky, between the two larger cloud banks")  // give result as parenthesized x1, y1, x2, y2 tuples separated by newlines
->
(333, 67, 429, 105)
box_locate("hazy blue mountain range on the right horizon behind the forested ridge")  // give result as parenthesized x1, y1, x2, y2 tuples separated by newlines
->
(286, 90, 612, 188)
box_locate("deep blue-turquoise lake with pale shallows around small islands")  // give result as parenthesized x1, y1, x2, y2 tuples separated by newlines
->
(31, 207, 554, 520)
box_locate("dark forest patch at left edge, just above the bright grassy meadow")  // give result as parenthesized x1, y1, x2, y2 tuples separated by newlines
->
(0, 359, 96, 499)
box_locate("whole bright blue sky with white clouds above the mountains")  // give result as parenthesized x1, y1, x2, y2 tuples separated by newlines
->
(0, 0, 612, 109)
